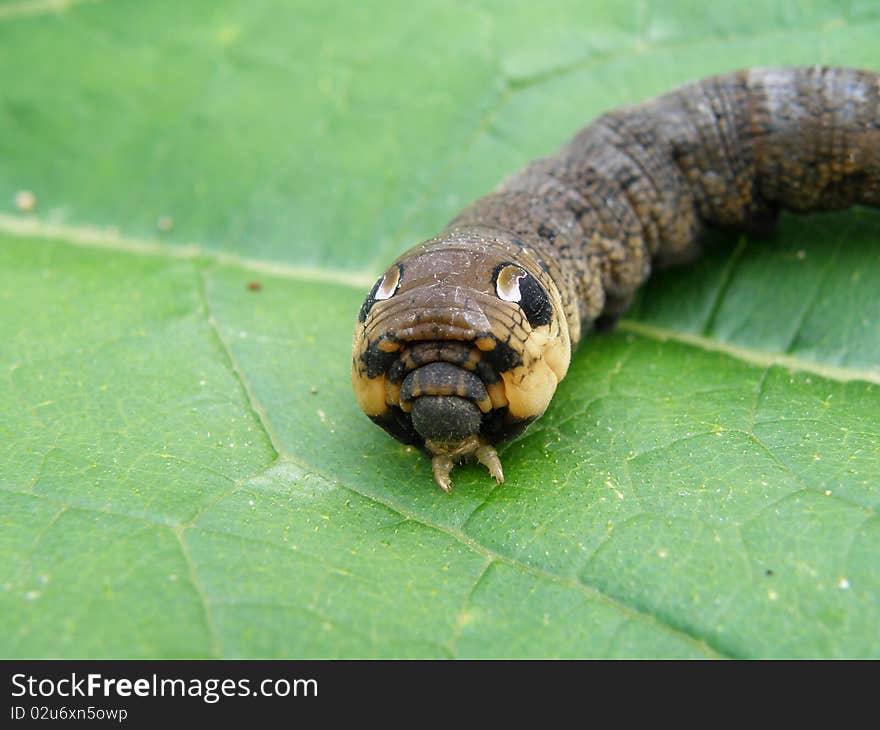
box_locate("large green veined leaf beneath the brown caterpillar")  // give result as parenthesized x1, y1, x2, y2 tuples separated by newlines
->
(0, 0, 880, 657)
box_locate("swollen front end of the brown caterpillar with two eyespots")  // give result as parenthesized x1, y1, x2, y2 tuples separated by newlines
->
(352, 230, 571, 491)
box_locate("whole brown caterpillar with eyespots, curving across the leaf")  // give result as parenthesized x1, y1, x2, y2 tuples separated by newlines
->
(352, 67, 880, 492)
